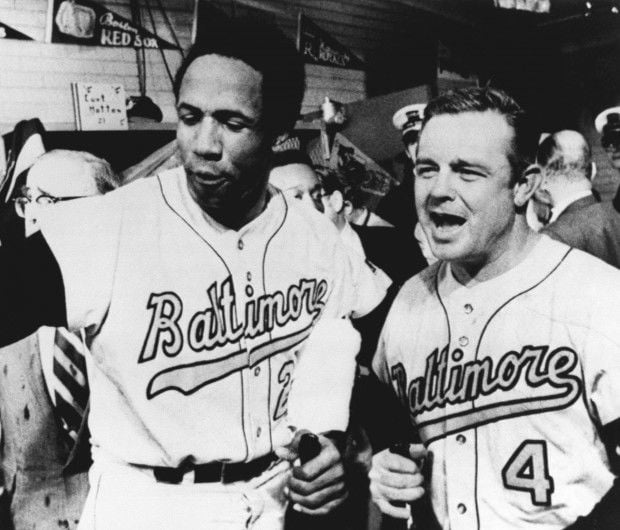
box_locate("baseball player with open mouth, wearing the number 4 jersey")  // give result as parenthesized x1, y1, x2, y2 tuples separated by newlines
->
(370, 88, 620, 530)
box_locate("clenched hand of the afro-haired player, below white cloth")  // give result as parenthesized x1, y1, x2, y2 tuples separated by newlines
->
(276, 431, 348, 515)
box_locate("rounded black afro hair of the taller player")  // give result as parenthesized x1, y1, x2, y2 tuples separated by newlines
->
(174, 17, 305, 138)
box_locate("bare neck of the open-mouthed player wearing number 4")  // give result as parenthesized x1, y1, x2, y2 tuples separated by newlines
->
(450, 224, 540, 285)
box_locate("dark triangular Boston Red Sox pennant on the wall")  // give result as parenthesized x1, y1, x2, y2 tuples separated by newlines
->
(51, 0, 178, 49)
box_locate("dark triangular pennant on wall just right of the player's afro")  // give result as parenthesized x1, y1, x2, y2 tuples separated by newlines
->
(297, 13, 364, 70)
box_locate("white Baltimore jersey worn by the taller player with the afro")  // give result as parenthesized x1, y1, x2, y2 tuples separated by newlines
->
(41, 168, 384, 466)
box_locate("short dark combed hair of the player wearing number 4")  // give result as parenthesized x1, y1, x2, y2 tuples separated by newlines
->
(420, 87, 539, 184)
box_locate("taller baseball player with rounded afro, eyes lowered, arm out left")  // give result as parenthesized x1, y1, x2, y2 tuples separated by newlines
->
(0, 19, 384, 530)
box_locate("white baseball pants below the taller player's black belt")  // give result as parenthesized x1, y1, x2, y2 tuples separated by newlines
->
(78, 456, 290, 530)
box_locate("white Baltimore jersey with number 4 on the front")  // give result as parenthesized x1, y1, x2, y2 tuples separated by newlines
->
(373, 236, 620, 530)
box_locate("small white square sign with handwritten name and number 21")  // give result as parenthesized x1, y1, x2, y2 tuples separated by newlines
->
(71, 83, 127, 131)
